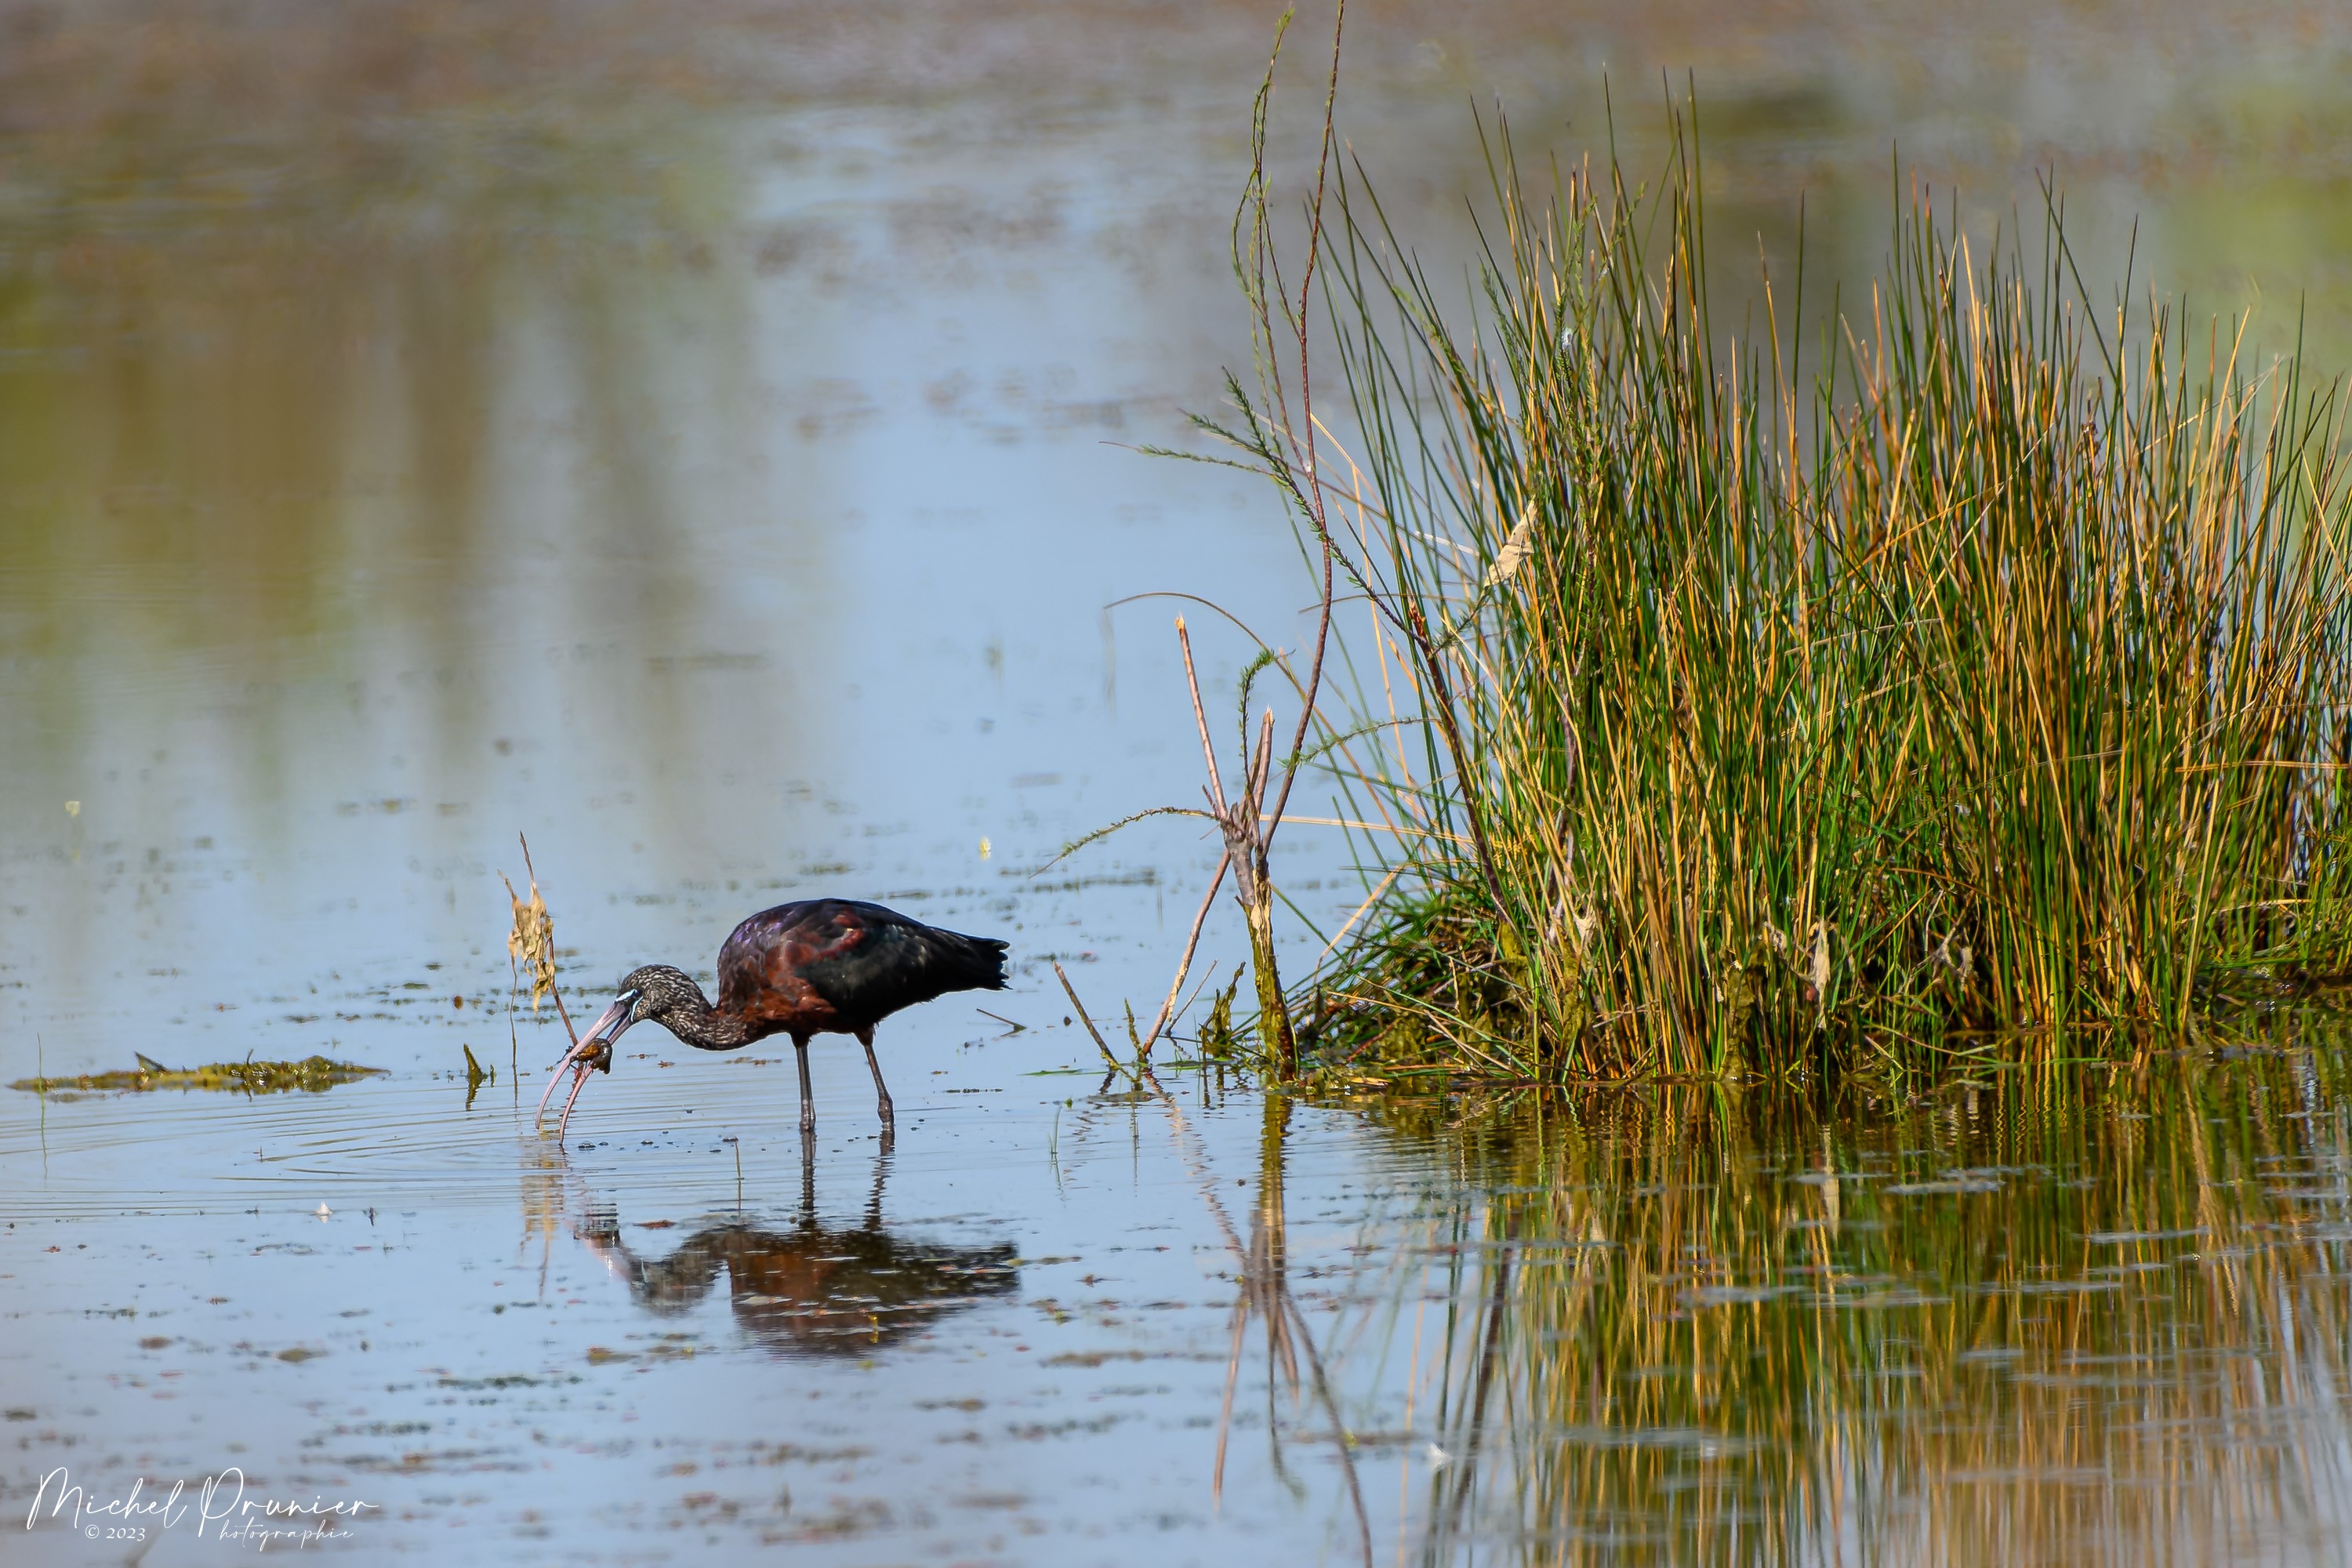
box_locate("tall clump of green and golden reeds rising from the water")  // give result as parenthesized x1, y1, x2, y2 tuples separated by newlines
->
(1289, 119, 2352, 1074)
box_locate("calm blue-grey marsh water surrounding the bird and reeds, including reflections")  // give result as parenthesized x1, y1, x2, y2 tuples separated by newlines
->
(0, 5, 2352, 1563)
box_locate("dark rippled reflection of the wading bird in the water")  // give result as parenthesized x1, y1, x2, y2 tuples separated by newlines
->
(579, 1152, 1021, 1356)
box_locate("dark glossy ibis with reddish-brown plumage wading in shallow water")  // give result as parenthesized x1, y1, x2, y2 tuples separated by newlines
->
(539, 898, 1004, 1138)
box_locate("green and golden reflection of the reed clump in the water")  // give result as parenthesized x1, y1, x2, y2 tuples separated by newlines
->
(1364, 1034, 2352, 1563)
